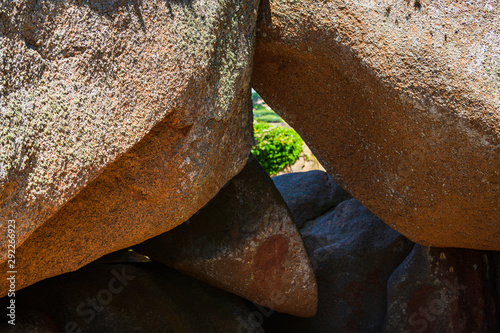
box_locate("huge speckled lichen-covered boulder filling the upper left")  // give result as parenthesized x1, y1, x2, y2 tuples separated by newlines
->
(0, 0, 257, 295)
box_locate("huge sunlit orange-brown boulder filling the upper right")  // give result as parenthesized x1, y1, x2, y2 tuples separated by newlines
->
(252, 0, 500, 250)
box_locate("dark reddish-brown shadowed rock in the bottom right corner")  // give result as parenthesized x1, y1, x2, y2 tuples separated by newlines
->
(382, 245, 498, 333)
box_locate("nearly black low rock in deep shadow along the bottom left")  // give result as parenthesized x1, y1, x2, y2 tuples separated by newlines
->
(0, 253, 252, 333)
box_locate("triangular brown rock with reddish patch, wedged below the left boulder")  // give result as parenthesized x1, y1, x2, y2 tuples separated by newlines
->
(134, 156, 318, 317)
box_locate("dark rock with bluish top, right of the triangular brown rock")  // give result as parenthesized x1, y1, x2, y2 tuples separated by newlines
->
(302, 199, 413, 333)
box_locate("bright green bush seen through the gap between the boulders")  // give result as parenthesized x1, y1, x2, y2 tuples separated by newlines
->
(252, 121, 303, 176)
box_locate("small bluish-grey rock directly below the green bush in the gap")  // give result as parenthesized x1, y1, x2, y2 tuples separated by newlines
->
(272, 170, 350, 228)
